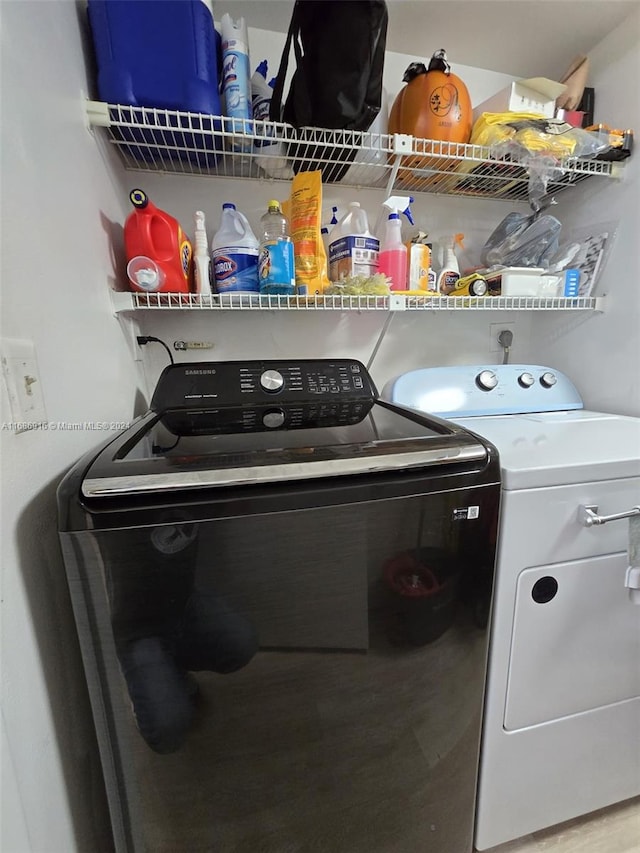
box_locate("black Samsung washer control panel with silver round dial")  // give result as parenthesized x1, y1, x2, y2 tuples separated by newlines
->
(151, 359, 378, 411)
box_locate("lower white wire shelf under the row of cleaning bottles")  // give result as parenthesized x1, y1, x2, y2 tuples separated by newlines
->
(112, 291, 604, 314)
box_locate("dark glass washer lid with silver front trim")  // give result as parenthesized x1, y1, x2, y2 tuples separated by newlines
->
(82, 398, 488, 497)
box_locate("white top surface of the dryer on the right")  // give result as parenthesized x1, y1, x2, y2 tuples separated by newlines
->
(455, 409, 640, 490)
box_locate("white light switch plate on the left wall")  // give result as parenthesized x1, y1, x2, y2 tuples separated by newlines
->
(0, 338, 47, 433)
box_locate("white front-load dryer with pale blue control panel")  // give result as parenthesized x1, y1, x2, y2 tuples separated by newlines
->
(382, 364, 640, 850)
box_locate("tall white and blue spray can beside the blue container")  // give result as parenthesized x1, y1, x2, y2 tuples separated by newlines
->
(221, 13, 252, 151)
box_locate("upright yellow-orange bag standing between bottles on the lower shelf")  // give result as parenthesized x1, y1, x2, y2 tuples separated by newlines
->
(282, 171, 330, 296)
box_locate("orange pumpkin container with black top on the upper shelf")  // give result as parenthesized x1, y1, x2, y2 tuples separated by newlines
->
(389, 50, 473, 185)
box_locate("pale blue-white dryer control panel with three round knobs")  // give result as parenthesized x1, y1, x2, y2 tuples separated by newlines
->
(381, 364, 583, 418)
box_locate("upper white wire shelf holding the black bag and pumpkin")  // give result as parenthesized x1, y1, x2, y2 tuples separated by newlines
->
(87, 101, 617, 201)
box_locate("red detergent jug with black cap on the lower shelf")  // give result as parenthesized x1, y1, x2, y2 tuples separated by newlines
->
(124, 189, 192, 293)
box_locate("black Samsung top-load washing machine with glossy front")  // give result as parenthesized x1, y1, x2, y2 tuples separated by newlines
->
(58, 359, 500, 853)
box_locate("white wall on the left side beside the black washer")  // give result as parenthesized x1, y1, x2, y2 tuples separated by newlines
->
(0, 0, 136, 853)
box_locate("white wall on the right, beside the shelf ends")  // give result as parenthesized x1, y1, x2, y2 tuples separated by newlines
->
(531, 8, 640, 416)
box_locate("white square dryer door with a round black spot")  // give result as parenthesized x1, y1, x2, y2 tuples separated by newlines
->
(504, 553, 640, 731)
